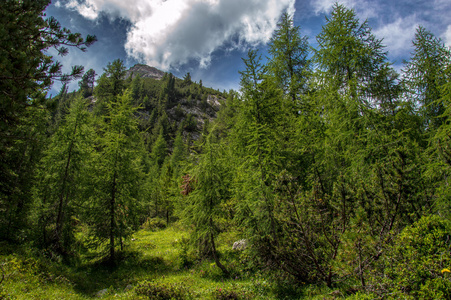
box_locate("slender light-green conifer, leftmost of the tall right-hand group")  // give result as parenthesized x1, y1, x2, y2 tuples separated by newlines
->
(231, 50, 286, 270)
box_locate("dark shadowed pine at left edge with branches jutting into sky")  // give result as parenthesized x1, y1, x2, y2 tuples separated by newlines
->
(0, 0, 96, 239)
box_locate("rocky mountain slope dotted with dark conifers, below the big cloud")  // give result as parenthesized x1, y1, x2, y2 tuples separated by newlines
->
(125, 64, 225, 146)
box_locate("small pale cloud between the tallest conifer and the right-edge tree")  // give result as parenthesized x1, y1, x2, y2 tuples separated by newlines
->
(374, 16, 418, 56)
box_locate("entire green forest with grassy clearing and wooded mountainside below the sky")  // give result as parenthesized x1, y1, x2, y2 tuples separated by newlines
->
(0, 0, 451, 299)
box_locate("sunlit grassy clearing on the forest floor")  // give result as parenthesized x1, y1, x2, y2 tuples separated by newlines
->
(0, 227, 338, 299)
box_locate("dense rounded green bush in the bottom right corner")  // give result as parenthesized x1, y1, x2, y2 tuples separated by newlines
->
(374, 215, 451, 299)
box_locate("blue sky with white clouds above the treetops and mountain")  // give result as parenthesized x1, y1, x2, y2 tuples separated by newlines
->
(46, 0, 451, 95)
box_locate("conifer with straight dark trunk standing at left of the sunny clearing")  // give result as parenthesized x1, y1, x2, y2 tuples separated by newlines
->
(86, 90, 144, 264)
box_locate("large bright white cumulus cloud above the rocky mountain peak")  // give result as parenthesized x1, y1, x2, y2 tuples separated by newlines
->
(58, 0, 295, 70)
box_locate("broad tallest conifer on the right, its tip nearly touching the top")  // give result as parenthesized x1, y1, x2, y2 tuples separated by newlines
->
(298, 4, 428, 287)
